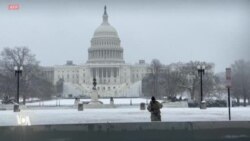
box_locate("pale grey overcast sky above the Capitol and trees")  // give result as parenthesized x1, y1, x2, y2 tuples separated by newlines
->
(0, 0, 250, 72)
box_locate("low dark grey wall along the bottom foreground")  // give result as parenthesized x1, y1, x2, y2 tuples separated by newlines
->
(0, 121, 250, 141)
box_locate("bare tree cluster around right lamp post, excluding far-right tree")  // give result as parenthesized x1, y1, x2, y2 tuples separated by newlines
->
(142, 59, 215, 101)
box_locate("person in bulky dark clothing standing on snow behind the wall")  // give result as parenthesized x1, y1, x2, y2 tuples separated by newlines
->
(147, 96, 162, 121)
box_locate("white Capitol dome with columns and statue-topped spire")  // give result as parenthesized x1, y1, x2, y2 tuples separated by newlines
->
(87, 6, 124, 63)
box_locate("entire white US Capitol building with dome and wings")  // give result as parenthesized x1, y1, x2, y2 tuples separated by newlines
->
(47, 6, 150, 97)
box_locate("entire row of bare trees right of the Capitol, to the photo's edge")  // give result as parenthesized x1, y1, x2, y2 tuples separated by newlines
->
(142, 59, 250, 106)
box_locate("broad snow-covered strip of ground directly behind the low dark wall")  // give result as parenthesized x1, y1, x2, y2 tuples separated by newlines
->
(0, 106, 250, 126)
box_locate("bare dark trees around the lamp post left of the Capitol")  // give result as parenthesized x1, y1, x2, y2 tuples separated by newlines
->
(0, 47, 55, 102)
